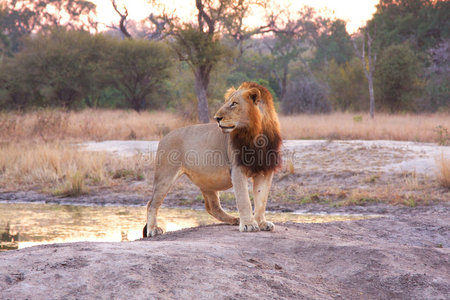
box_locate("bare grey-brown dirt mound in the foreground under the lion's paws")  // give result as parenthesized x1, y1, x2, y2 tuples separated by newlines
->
(0, 207, 450, 299)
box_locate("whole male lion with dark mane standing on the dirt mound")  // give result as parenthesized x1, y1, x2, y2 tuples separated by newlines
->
(143, 82, 282, 237)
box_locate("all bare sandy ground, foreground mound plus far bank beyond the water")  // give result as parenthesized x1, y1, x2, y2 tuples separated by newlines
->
(0, 141, 450, 299)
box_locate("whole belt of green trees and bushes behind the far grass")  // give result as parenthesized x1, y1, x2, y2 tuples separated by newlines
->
(0, 0, 450, 122)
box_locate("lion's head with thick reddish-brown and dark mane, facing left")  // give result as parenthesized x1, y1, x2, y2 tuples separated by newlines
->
(214, 82, 281, 175)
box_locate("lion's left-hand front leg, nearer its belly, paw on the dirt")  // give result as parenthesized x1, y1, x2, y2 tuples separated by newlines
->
(231, 167, 259, 232)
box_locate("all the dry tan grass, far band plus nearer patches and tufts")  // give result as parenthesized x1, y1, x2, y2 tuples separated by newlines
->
(0, 110, 450, 198)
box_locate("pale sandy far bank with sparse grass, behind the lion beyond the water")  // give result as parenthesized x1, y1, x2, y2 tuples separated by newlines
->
(82, 140, 450, 205)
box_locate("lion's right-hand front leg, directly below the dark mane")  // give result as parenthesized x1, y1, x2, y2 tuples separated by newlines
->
(253, 172, 275, 231)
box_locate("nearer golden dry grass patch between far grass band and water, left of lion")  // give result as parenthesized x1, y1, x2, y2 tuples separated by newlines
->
(0, 143, 153, 196)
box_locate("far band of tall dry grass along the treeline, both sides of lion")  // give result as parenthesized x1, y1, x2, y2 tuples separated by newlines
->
(0, 109, 450, 145)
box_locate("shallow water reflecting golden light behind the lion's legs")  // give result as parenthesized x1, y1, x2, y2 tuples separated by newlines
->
(0, 203, 368, 251)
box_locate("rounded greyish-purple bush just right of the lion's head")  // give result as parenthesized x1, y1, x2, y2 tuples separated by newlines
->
(281, 77, 331, 114)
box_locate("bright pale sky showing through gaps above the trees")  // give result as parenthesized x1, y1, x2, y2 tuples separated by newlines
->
(91, 0, 378, 33)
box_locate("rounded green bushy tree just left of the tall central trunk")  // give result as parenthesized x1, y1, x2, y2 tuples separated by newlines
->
(108, 39, 172, 112)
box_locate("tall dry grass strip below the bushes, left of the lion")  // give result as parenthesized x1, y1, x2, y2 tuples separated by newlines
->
(0, 109, 187, 142)
